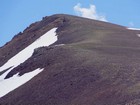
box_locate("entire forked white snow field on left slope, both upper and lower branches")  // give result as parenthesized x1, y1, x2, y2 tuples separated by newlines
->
(0, 28, 58, 97)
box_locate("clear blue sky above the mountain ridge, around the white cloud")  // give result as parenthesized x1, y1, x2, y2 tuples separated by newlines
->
(0, 0, 140, 46)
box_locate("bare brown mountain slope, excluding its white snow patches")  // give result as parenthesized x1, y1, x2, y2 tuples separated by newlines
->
(0, 15, 140, 105)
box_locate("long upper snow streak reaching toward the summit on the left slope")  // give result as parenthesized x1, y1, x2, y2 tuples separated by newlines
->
(0, 28, 58, 79)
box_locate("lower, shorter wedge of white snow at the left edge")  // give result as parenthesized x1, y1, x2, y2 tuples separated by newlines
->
(0, 69, 43, 97)
